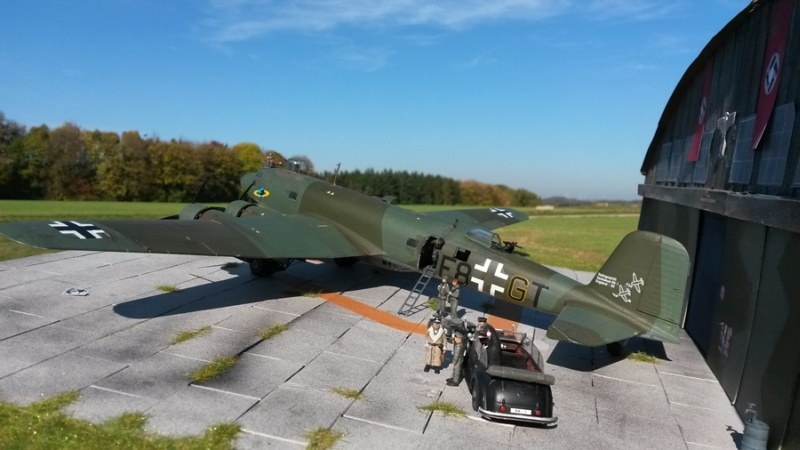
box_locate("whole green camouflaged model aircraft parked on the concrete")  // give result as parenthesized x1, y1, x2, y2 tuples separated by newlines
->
(0, 160, 689, 346)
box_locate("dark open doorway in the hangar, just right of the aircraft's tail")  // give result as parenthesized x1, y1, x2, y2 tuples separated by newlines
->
(685, 211, 727, 356)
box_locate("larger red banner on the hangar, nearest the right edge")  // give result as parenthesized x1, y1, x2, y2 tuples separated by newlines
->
(752, 0, 794, 150)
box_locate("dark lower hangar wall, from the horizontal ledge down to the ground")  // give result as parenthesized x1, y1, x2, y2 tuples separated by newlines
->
(639, 198, 800, 449)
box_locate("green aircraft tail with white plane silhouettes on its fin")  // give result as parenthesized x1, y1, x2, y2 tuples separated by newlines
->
(547, 231, 689, 346)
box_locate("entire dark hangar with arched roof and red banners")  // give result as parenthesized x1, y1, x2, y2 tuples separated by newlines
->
(639, 0, 800, 449)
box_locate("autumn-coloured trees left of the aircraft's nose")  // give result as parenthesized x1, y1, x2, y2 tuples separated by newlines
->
(0, 113, 264, 202)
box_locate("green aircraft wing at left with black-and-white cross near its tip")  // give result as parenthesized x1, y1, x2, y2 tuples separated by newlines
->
(0, 212, 369, 258)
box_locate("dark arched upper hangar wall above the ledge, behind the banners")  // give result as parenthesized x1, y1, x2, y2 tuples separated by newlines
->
(642, 1, 800, 198)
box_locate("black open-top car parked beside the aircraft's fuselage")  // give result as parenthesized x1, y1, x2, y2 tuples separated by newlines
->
(464, 324, 558, 425)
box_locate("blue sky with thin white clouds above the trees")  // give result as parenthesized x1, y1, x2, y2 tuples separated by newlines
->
(0, 0, 749, 199)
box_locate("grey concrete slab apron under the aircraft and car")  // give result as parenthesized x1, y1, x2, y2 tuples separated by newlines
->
(0, 252, 743, 449)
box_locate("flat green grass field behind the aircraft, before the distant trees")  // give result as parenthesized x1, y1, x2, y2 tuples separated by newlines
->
(0, 200, 639, 271)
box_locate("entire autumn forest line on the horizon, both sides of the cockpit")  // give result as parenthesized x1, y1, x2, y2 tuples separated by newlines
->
(0, 113, 540, 206)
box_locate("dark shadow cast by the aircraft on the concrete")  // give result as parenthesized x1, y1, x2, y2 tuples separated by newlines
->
(114, 263, 668, 371)
